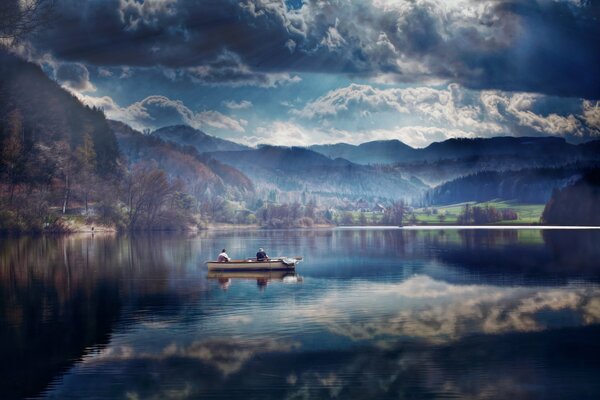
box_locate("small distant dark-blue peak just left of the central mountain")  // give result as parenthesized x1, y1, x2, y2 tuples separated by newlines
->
(152, 125, 250, 153)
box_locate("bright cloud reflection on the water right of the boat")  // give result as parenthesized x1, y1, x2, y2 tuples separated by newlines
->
(298, 275, 600, 343)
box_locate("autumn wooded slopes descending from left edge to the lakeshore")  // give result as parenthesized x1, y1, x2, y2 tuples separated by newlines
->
(0, 53, 254, 233)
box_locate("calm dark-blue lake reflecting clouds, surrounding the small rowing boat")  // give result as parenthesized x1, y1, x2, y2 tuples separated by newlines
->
(0, 229, 600, 399)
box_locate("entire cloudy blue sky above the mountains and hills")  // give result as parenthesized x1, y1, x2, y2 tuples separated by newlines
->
(19, 0, 600, 147)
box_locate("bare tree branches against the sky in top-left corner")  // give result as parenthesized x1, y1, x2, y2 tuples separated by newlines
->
(0, 0, 56, 44)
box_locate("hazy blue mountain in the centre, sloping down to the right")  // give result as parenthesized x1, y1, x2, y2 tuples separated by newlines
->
(210, 146, 427, 200)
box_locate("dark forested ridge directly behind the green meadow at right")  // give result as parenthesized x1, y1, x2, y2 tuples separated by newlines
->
(425, 163, 590, 205)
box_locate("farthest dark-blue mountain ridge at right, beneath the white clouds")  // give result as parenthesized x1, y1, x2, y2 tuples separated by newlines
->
(310, 136, 600, 186)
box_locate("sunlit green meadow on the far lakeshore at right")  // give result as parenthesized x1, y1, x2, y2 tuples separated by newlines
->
(344, 200, 544, 225)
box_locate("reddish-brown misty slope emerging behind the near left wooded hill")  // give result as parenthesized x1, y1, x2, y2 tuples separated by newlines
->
(109, 121, 254, 198)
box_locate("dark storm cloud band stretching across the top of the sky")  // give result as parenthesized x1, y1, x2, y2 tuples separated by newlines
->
(32, 0, 600, 99)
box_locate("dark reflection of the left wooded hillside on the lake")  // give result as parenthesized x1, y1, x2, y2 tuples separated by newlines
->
(0, 236, 197, 398)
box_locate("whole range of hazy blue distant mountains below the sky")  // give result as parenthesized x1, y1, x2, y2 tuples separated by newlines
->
(139, 121, 600, 203)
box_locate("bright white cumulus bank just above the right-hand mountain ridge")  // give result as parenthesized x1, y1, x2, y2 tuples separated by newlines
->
(291, 84, 600, 143)
